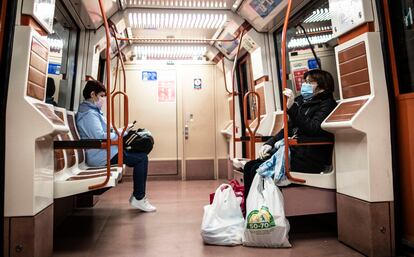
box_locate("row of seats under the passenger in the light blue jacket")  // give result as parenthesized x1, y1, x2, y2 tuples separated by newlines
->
(54, 107, 124, 198)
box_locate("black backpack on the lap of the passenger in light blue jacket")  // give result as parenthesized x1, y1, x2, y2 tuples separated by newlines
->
(123, 129, 154, 154)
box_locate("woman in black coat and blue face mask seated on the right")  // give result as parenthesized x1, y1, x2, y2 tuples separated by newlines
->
(244, 70, 336, 199)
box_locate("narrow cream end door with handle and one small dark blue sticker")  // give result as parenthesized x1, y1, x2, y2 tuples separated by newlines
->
(179, 65, 216, 180)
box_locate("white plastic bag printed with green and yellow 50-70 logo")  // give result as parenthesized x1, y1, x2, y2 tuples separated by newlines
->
(243, 174, 291, 247)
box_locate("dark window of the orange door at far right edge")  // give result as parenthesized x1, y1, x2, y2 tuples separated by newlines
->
(389, 0, 414, 94)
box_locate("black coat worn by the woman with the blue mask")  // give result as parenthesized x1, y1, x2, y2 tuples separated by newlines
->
(265, 92, 336, 173)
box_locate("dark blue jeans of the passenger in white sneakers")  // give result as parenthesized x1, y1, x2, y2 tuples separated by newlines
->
(111, 150, 148, 200)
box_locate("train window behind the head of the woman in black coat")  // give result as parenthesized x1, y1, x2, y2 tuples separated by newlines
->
(274, 0, 339, 107)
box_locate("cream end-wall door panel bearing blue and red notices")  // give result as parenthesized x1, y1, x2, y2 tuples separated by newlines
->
(126, 65, 181, 177)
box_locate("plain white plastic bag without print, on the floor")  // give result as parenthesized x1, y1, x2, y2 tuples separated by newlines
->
(201, 184, 244, 245)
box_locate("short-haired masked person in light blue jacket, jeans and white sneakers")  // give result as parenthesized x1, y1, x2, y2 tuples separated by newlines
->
(76, 81, 156, 212)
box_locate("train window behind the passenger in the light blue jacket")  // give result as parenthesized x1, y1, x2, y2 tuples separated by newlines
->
(46, 1, 79, 109)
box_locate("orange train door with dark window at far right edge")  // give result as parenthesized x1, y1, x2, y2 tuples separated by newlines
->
(383, 0, 414, 248)
